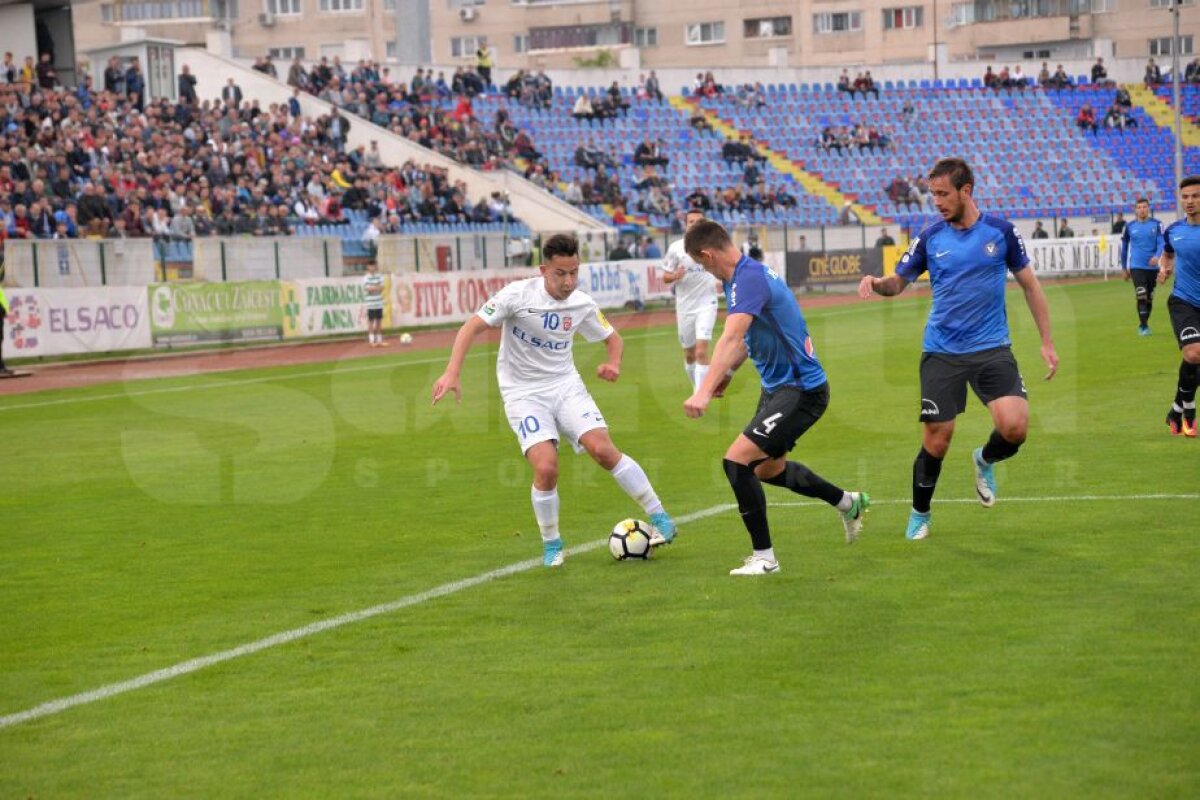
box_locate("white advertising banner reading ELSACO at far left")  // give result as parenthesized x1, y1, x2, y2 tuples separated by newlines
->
(4, 287, 150, 359)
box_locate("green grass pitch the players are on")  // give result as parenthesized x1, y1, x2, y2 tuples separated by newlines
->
(0, 282, 1200, 799)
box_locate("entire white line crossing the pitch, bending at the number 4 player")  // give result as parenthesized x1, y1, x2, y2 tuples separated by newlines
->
(0, 494, 1200, 729)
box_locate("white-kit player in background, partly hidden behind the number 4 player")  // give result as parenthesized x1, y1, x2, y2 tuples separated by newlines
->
(662, 209, 728, 397)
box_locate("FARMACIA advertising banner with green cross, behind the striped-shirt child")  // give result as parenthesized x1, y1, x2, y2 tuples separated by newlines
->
(283, 275, 392, 338)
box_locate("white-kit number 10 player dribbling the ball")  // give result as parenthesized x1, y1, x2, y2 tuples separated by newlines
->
(433, 234, 676, 566)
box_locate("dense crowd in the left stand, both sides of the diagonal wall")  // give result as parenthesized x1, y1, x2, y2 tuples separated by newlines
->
(0, 59, 528, 248)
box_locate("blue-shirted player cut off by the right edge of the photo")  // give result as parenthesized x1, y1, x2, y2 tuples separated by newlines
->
(1158, 175, 1200, 439)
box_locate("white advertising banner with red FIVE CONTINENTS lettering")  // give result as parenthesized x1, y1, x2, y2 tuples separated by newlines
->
(390, 267, 537, 327)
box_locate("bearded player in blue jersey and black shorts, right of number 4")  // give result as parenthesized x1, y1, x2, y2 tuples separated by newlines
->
(858, 158, 1058, 540)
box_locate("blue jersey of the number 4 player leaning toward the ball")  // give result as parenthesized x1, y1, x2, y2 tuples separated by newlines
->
(725, 255, 827, 392)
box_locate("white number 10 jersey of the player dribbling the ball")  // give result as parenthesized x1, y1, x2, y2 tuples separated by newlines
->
(476, 276, 613, 402)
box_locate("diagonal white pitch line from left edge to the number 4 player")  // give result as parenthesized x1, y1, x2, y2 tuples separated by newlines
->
(0, 504, 736, 728)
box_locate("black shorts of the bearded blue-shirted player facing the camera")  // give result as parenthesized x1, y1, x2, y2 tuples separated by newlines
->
(920, 347, 1027, 422)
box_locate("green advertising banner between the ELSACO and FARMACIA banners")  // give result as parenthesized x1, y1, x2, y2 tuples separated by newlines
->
(145, 281, 282, 347)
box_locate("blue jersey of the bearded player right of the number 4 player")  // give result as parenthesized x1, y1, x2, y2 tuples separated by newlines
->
(896, 213, 1030, 355)
